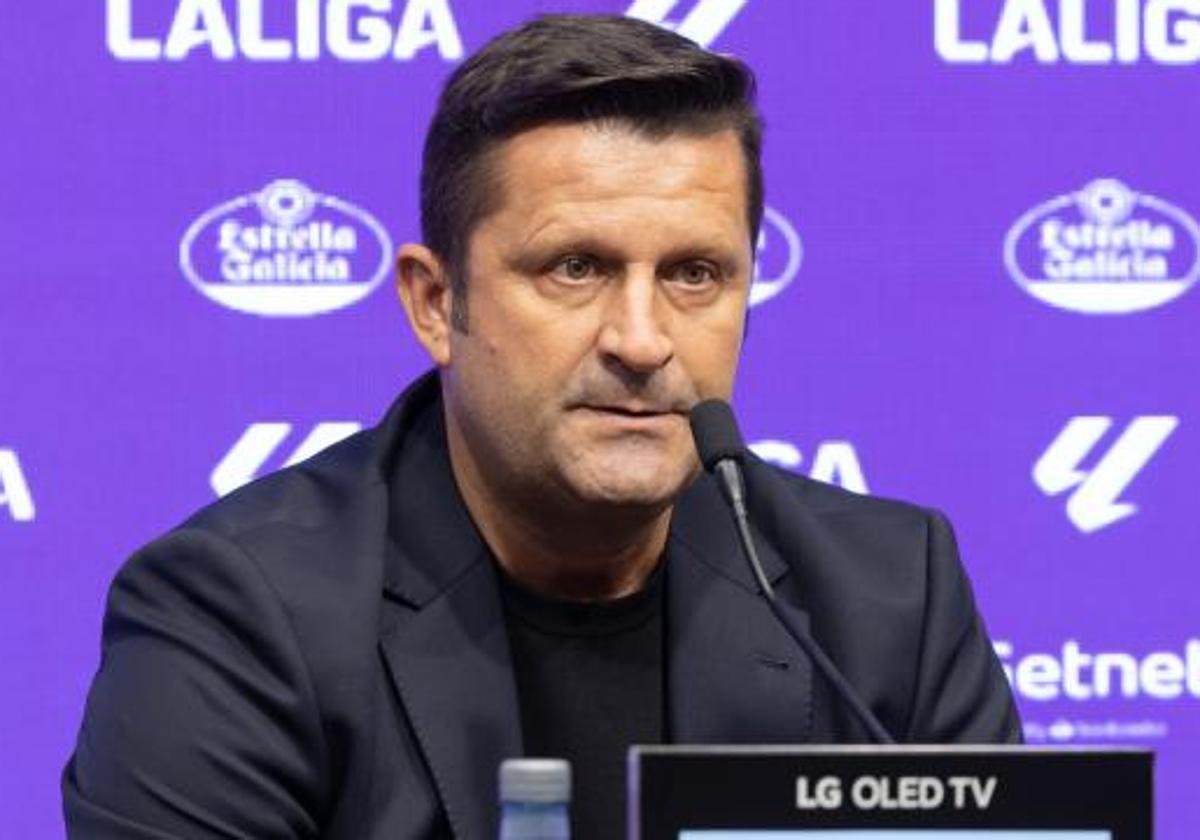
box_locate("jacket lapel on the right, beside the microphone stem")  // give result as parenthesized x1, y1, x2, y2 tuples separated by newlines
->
(667, 476, 812, 744)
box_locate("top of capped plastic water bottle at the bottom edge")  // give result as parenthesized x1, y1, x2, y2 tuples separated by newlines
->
(500, 758, 571, 840)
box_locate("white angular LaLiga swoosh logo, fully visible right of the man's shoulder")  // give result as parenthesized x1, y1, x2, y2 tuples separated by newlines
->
(1033, 416, 1180, 534)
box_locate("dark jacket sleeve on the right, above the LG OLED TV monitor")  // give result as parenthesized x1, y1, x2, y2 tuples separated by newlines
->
(904, 512, 1021, 744)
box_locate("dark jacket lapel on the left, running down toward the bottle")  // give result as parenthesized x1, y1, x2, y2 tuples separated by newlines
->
(380, 379, 522, 838)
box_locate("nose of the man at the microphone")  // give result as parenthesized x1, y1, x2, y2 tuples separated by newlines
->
(599, 270, 674, 373)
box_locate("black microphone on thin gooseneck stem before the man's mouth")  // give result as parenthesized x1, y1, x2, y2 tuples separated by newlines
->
(690, 400, 895, 744)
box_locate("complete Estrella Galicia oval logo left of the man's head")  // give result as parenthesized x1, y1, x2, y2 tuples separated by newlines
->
(179, 179, 392, 317)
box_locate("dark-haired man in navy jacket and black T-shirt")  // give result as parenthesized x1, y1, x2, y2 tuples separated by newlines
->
(64, 17, 1019, 839)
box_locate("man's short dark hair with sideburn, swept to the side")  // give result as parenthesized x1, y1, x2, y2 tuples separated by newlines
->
(421, 14, 763, 330)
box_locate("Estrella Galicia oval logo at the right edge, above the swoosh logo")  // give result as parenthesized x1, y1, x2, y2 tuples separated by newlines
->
(1004, 178, 1200, 314)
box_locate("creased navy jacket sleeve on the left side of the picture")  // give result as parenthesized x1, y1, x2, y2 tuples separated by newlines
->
(62, 529, 326, 839)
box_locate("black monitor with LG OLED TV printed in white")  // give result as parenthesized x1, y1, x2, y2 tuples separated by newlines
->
(629, 746, 1153, 840)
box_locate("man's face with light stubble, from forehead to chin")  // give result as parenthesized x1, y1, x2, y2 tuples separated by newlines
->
(443, 124, 752, 509)
